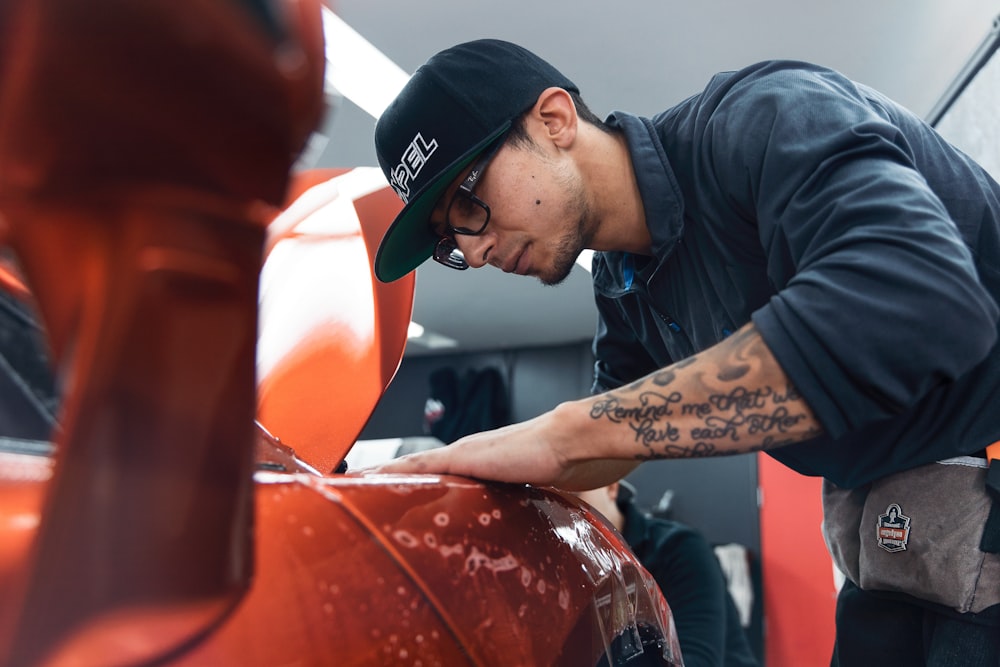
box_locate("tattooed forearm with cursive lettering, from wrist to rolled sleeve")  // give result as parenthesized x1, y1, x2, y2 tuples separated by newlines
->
(567, 323, 822, 460)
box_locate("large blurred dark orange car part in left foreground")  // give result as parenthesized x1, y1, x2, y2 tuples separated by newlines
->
(0, 0, 325, 667)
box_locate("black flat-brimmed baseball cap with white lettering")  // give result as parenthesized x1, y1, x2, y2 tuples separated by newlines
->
(375, 39, 579, 282)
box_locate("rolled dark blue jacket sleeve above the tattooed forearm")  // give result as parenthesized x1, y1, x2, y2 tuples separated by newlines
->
(706, 62, 998, 437)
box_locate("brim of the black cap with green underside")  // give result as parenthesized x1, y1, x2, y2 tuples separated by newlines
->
(375, 122, 510, 283)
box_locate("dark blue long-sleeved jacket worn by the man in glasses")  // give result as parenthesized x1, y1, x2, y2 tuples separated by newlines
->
(593, 61, 1000, 487)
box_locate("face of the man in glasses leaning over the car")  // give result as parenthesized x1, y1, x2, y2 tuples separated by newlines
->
(431, 136, 593, 285)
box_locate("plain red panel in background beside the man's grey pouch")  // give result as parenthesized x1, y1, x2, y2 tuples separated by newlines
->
(757, 454, 837, 667)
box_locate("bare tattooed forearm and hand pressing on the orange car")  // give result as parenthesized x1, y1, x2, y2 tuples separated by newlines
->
(375, 324, 822, 491)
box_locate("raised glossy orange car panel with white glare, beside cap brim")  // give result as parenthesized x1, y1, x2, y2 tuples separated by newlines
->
(257, 167, 415, 472)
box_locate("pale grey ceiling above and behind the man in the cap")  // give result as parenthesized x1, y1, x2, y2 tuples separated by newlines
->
(313, 0, 1000, 356)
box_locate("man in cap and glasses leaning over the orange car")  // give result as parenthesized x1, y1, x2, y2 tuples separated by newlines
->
(375, 40, 1000, 665)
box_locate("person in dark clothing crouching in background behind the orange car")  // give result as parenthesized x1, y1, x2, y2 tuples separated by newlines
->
(576, 482, 759, 667)
